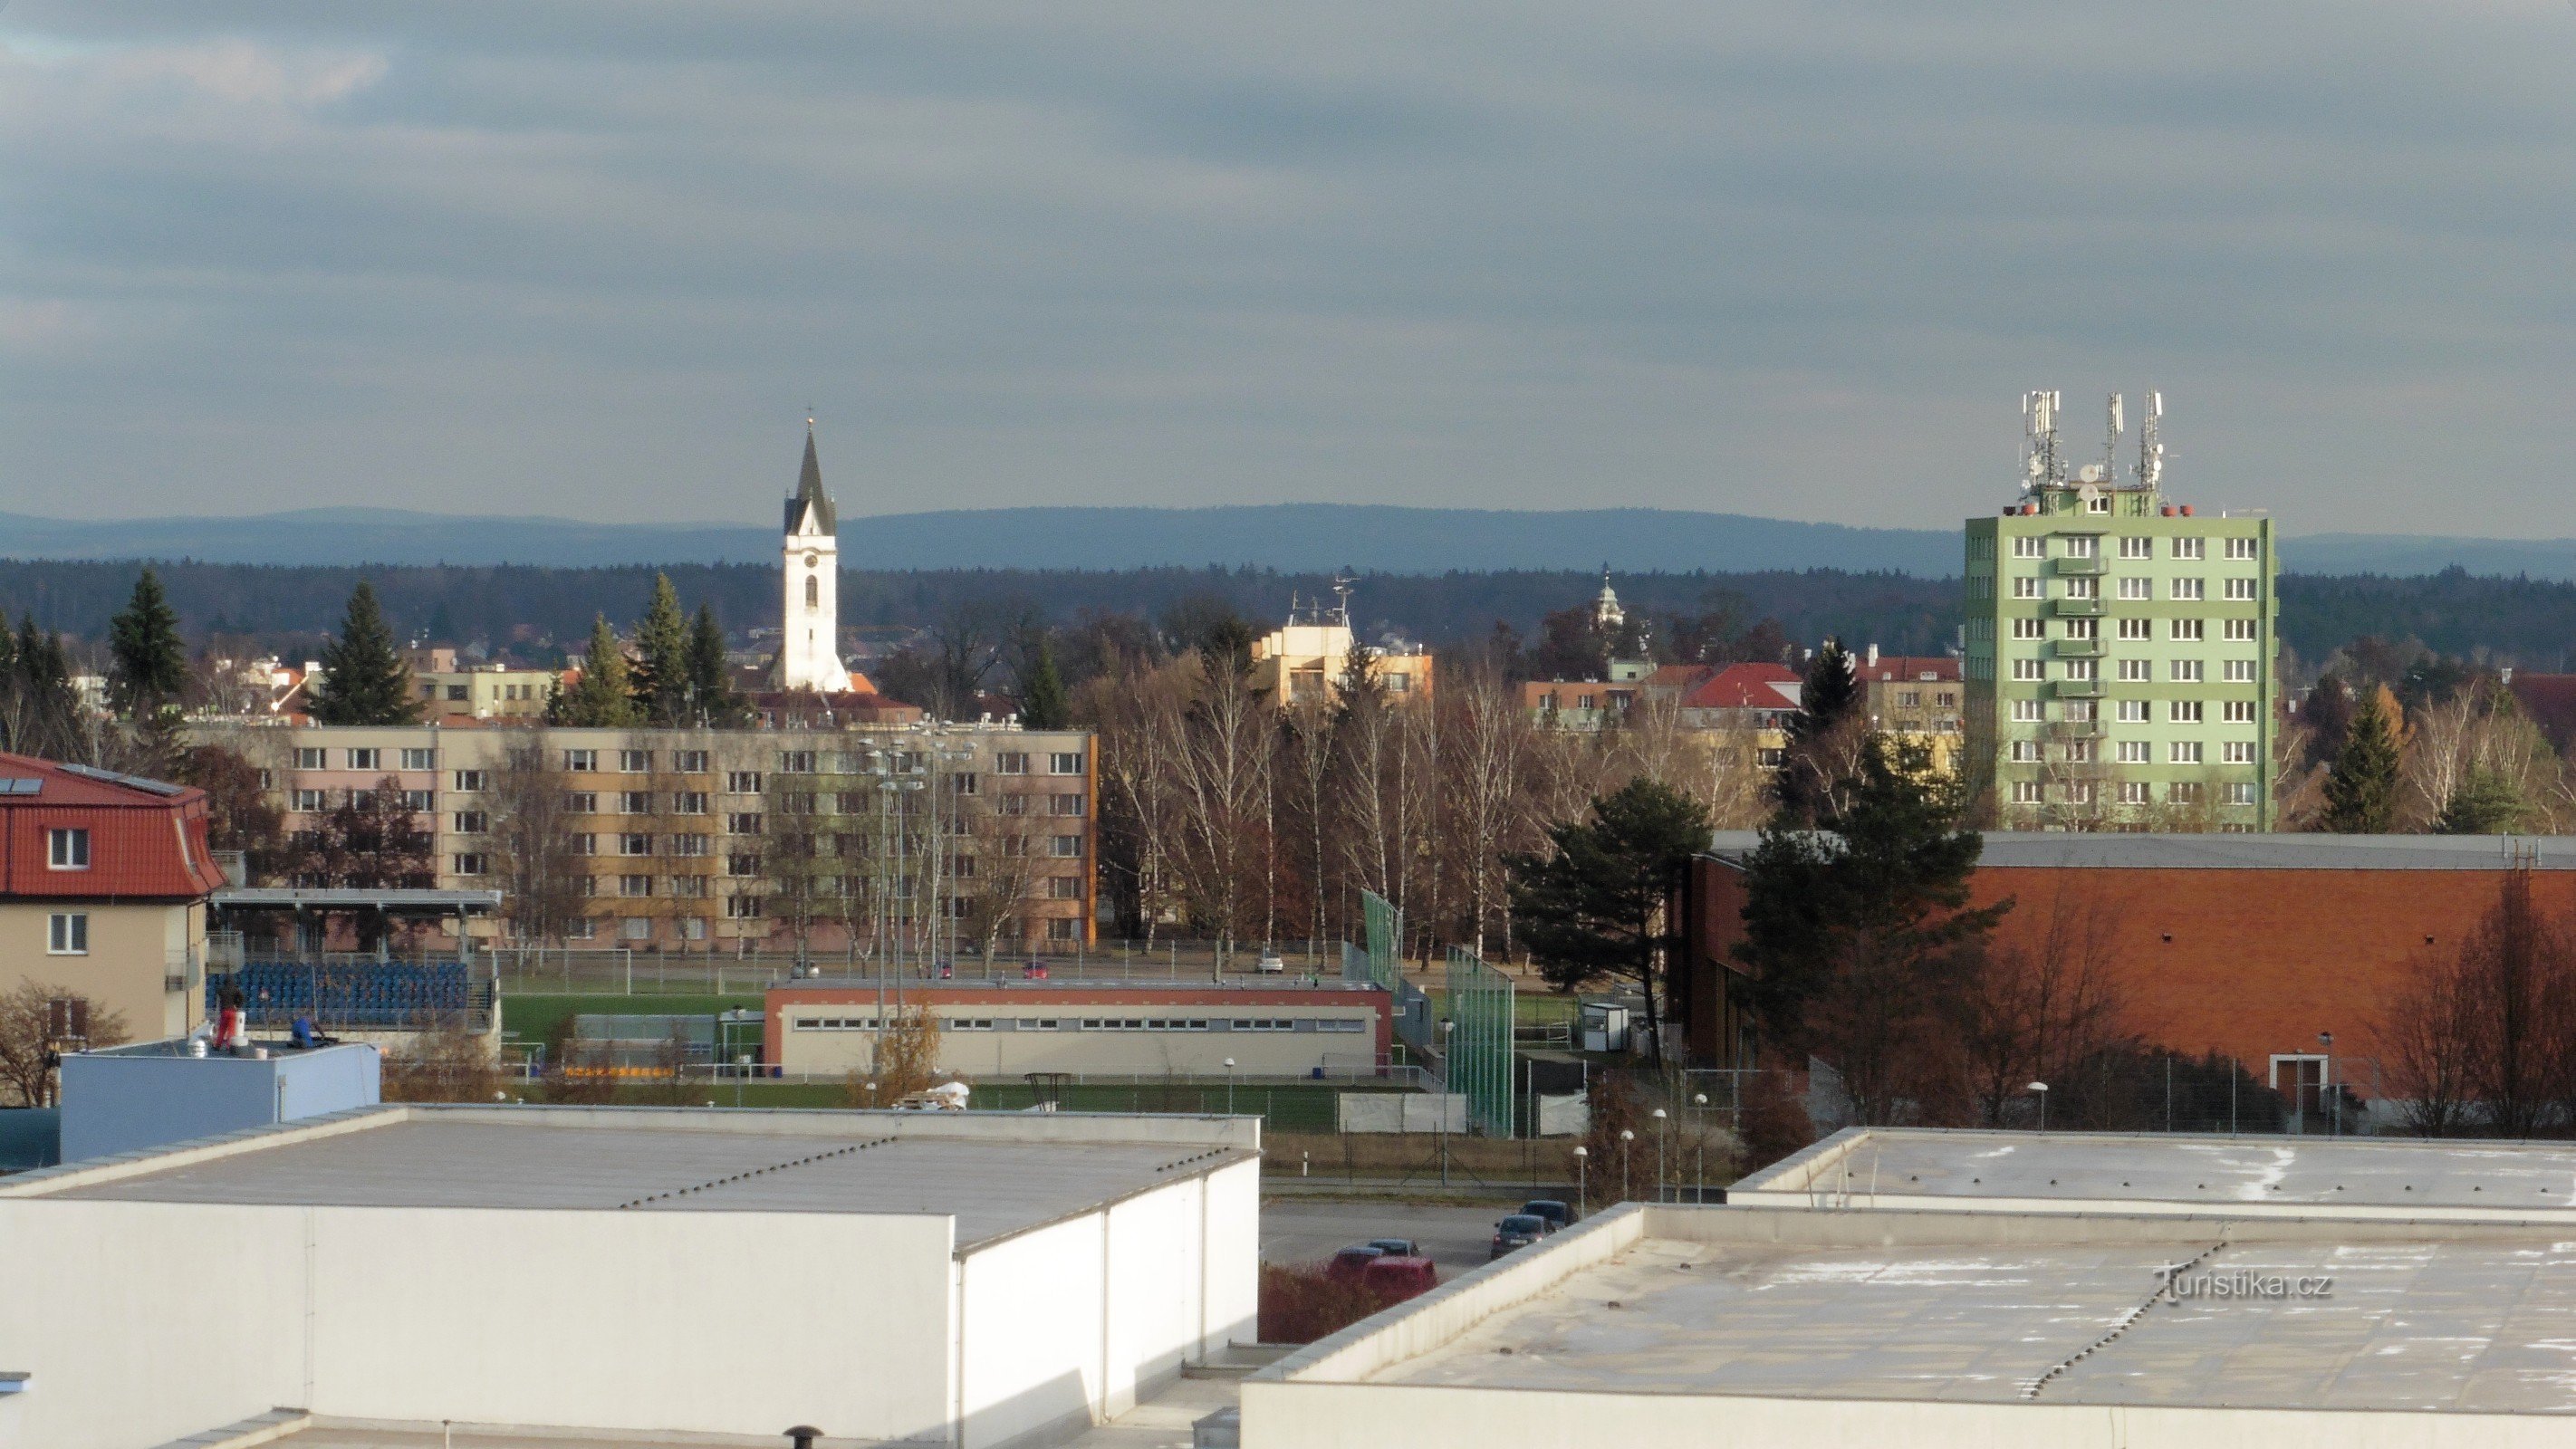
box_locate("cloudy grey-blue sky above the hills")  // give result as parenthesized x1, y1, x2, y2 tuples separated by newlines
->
(0, 0, 2576, 538)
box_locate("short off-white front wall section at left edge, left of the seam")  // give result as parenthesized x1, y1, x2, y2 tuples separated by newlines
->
(0, 1199, 304, 1449)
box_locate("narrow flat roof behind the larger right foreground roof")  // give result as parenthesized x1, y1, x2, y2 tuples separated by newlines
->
(1736, 1130, 2576, 1217)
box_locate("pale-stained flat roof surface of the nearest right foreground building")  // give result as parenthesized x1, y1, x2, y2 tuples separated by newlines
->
(1368, 1230, 2576, 1413)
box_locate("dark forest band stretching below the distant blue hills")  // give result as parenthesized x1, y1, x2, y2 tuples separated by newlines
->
(0, 559, 2576, 677)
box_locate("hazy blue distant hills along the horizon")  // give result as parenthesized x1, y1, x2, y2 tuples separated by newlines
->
(0, 504, 2576, 579)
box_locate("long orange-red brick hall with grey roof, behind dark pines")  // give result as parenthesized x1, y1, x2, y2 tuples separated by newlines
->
(1675, 831, 2576, 1097)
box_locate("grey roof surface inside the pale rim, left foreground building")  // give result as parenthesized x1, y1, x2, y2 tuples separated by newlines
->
(43, 1117, 1246, 1248)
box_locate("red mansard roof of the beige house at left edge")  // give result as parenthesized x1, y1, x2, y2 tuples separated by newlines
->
(0, 754, 224, 901)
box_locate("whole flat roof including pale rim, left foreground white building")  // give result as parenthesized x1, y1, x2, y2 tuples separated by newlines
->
(8, 1107, 1252, 1248)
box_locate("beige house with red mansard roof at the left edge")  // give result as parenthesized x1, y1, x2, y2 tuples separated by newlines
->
(0, 754, 224, 1040)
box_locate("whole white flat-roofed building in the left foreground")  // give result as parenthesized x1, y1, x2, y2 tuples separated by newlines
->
(0, 1107, 1260, 1449)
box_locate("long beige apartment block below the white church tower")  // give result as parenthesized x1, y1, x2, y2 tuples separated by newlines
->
(190, 721, 1098, 960)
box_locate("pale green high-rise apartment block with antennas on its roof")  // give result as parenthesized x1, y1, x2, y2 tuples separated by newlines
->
(1960, 394, 2277, 831)
